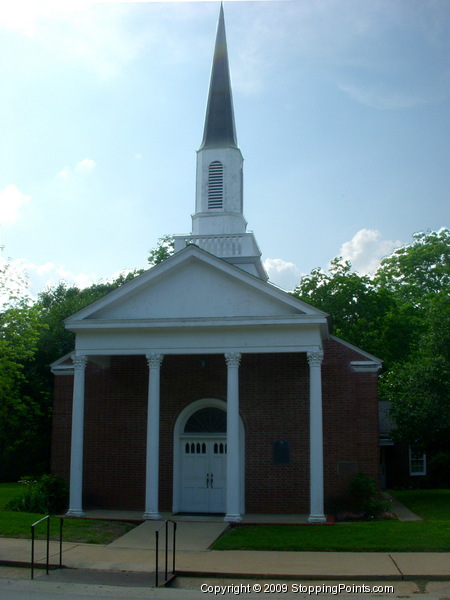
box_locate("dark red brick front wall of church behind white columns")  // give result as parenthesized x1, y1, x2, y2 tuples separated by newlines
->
(52, 340, 379, 513)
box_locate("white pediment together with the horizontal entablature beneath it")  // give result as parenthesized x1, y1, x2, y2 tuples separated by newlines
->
(66, 245, 328, 355)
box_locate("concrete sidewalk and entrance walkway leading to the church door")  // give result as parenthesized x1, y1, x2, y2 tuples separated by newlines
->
(0, 513, 450, 581)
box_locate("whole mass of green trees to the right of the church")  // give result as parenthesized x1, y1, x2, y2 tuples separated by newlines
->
(294, 229, 450, 452)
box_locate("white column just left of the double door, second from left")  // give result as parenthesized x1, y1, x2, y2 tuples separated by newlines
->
(144, 354, 164, 520)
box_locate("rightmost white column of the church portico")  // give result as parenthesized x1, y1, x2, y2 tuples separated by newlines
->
(307, 351, 326, 523)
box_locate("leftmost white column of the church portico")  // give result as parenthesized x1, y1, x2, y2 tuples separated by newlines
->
(67, 354, 87, 517)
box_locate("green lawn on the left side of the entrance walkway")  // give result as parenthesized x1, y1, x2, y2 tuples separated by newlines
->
(0, 483, 135, 544)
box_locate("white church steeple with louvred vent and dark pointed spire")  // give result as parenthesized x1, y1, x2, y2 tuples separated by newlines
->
(175, 5, 268, 281)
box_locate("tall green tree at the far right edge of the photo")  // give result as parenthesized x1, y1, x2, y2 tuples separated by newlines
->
(374, 229, 450, 453)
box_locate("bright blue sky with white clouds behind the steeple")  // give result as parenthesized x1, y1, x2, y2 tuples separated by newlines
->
(0, 0, 450, 293)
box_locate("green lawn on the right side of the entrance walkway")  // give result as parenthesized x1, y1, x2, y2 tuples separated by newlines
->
(214, 490, 450, 552)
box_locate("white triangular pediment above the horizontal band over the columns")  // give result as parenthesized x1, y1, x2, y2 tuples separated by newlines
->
(66, 245, 325, 328)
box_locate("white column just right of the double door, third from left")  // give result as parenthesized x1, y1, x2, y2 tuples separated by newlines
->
(224, 353, 242, 522)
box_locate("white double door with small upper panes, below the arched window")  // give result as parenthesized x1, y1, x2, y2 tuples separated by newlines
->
(180, 437, 227, 513)
